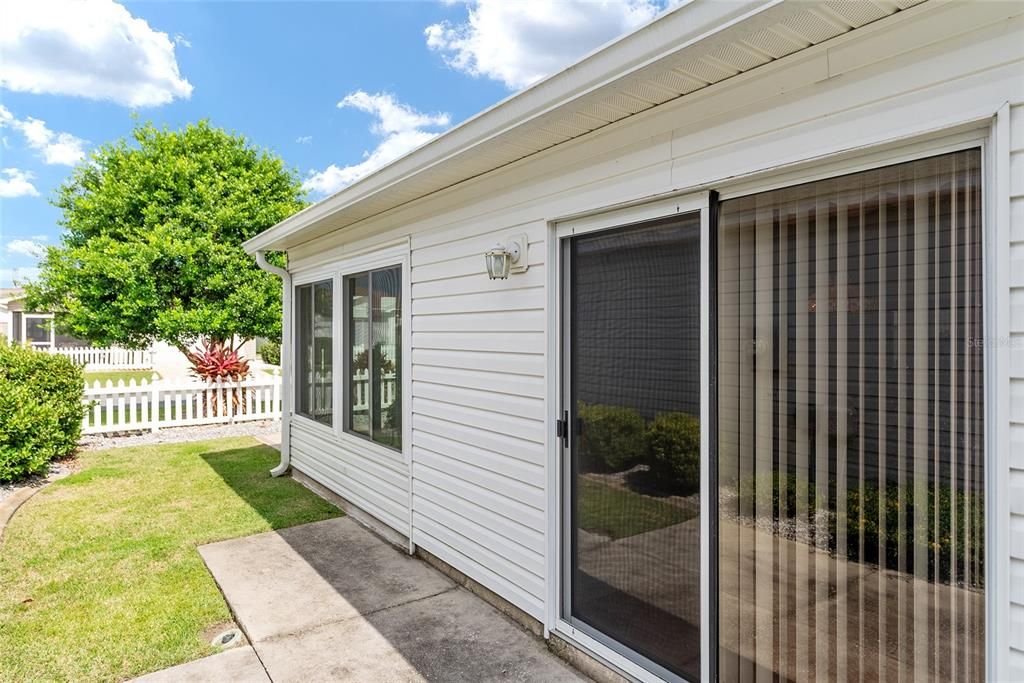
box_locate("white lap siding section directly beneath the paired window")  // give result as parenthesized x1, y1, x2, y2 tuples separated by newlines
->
(291, 418, 409, 536)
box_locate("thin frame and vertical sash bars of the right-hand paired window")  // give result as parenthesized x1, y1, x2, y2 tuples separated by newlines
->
(340, 263, 408, 453)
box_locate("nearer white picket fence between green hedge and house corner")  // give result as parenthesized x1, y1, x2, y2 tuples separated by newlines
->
(82, 373, 282, 434)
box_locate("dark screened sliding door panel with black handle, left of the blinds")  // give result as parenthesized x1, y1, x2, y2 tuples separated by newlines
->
(563, 212, 701, 680)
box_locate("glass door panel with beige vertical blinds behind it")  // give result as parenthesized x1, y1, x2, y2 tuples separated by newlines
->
(718, 150, 984, 681)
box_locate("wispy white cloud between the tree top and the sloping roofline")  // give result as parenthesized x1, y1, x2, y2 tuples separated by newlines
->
(302, 90, 452, 196)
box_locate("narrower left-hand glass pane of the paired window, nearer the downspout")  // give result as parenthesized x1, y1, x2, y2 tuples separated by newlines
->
(295, 280, 334, 425)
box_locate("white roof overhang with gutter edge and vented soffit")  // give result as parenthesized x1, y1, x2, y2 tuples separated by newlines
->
(245, 0, 924, 252)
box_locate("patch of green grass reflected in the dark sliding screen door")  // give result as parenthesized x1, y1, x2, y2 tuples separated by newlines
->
(577, 477, 696, 540)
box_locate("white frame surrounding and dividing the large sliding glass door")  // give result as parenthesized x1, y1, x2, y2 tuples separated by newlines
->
(545, 122, 1010, 682)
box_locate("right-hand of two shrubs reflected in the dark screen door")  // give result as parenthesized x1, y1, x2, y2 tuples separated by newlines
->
(646, 413, 700, 494)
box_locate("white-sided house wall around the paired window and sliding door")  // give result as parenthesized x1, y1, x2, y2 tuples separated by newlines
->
(282, 3, 1024, 679)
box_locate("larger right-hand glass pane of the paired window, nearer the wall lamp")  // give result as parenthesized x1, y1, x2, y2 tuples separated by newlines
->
(345, 266, 401, 451)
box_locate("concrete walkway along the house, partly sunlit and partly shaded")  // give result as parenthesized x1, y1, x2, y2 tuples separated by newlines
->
(142, 517, 586, 683)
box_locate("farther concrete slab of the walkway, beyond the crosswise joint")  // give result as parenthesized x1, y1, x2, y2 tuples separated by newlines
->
(199, 517, 455, 642)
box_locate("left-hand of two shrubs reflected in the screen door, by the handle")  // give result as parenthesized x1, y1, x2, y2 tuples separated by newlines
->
(578, 401, 644, 472)
